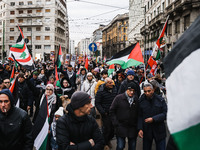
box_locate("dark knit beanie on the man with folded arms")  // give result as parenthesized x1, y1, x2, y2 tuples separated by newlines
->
(71, 91, 91, 110)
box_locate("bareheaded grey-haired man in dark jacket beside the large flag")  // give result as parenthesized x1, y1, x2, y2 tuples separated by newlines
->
(138, 83, 167, 150)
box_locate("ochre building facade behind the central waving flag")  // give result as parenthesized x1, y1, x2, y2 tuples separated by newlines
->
(102, 13, 129, 58)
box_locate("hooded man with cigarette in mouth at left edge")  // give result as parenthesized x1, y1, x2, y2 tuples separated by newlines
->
(0, 89, 33, 150)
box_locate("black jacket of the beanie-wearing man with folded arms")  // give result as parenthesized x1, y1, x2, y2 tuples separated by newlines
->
(56, 104, 104, 150)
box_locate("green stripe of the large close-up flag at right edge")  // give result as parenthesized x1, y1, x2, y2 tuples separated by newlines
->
(172, 123, 200, 150)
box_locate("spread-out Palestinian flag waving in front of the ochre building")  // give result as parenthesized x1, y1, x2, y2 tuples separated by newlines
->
(107, 43, 144, 69)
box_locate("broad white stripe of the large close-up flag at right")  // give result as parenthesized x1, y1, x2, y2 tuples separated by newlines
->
(166, 49, 200, 134)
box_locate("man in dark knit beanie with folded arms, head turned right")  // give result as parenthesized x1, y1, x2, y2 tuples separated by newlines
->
(56, 91, 104, 150)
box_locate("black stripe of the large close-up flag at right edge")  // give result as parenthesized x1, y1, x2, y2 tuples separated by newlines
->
(164, 16, 200, 78)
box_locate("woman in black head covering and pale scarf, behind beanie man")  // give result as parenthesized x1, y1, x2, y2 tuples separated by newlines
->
(57, 77, 75, 99)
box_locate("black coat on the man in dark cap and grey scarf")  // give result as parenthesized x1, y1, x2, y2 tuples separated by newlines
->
(110, 93, 139, 138)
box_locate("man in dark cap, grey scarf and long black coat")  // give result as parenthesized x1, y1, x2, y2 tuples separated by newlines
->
(110, 82, 139, 150)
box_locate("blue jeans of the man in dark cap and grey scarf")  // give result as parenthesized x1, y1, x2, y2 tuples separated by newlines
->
(116, 137, 136, 150)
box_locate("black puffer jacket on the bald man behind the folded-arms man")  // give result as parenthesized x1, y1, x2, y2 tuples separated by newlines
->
(95, 84, 117, 115)
